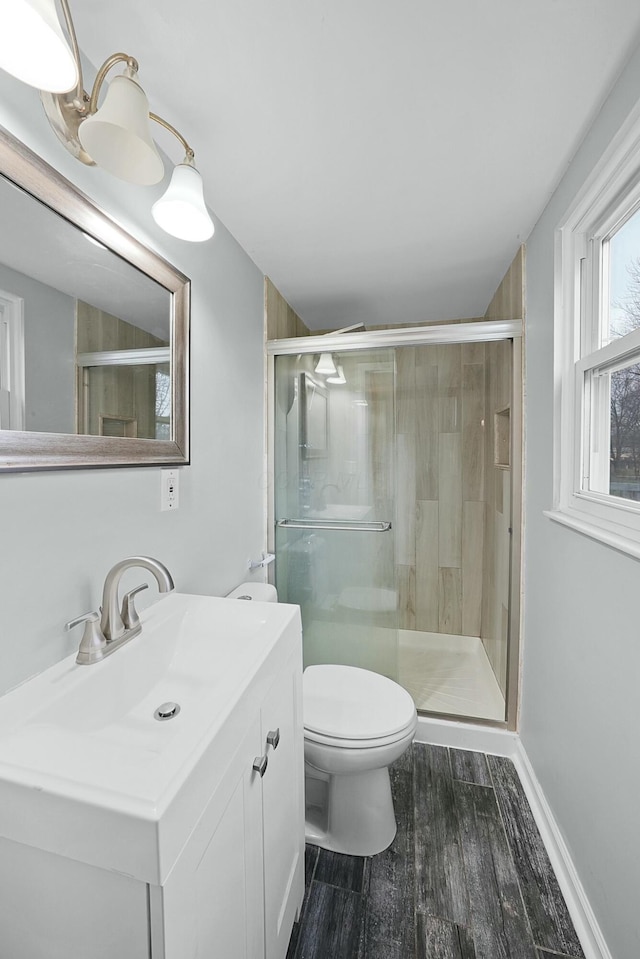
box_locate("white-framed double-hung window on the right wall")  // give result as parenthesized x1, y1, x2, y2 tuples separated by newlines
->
(547, 102, 640, 556)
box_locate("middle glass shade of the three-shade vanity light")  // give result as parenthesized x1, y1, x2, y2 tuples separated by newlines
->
(78, 75, 164, 186)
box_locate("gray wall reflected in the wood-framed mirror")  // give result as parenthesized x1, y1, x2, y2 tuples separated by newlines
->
(0, 263, 76, 433)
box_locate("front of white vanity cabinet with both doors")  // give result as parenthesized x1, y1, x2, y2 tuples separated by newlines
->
(156, 655, 304, 959)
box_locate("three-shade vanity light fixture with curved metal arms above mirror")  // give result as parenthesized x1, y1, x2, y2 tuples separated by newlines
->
(0, 0, 214, 241)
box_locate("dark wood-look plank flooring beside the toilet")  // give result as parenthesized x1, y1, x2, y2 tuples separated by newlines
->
(287, 743, 584, 959)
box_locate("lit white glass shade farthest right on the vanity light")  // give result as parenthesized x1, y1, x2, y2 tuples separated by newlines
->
(151, 163, 214, 242)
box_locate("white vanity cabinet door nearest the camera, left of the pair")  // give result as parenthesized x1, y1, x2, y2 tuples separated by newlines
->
(159, 716, 264, 959)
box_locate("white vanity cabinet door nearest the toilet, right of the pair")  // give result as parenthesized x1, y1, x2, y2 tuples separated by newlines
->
(261, 655, 304, 959)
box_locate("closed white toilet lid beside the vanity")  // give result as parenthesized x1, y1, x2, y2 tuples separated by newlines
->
(303, 666, 416, 739)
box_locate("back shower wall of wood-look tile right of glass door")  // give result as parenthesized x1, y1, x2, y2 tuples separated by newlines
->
(396, 344, 486, 636)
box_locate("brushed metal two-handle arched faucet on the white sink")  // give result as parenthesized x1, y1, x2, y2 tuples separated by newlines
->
(65, 556, 174, 666)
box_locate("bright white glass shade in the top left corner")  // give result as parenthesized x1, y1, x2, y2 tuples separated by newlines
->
(0, 0, 78, 93)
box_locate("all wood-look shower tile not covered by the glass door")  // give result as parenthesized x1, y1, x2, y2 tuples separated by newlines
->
(265, 247, 524, 692)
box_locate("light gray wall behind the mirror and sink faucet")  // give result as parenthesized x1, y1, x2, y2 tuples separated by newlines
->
(0, 71, 264, 691)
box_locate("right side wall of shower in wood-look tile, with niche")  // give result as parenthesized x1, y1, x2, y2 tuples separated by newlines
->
(480, 247, 524, 694)
